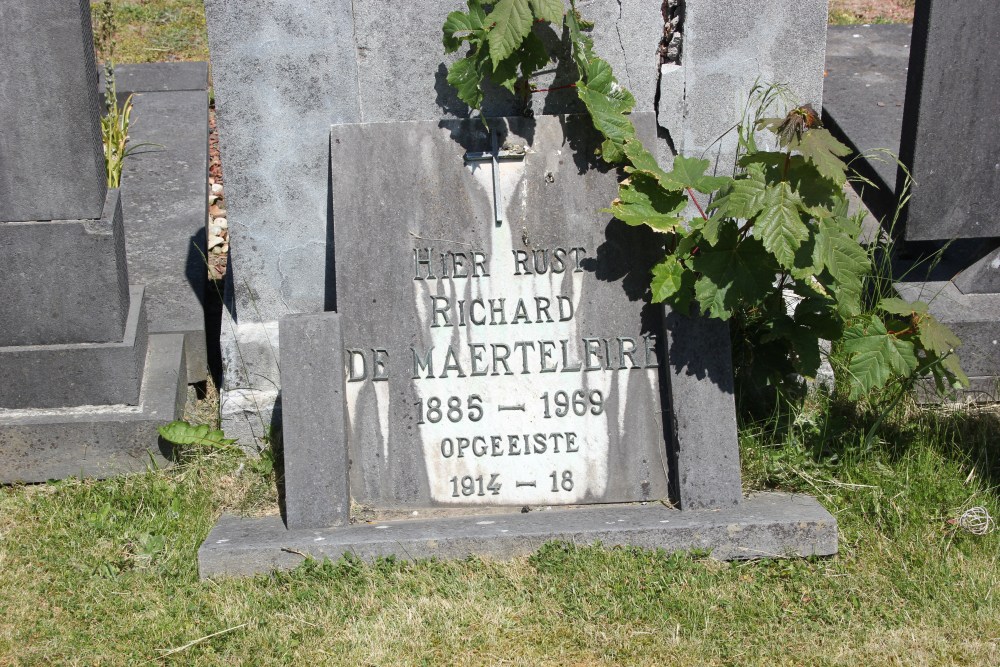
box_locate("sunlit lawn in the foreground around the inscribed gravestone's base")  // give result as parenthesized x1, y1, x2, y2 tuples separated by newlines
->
(0, 394, 1000, 665)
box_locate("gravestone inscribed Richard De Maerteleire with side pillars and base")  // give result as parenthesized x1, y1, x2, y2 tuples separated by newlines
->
(199, 113, 837, 577)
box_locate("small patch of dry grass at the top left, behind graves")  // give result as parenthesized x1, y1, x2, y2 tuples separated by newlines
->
(91, 0, 208, 65)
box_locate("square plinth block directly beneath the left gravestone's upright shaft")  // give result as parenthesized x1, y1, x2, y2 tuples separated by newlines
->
(0, 190, 129, 346)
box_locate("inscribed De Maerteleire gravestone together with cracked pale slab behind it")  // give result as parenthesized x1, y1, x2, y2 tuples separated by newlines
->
(199, 0, 837, 577)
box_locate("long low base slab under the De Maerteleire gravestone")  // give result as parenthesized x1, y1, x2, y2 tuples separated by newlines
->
(198, 493, 837, 578)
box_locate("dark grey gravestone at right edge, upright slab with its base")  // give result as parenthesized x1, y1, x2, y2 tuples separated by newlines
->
(897, 0, 1000, 401)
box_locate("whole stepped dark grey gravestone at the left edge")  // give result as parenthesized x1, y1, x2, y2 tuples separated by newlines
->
(0, 0, 186, 482)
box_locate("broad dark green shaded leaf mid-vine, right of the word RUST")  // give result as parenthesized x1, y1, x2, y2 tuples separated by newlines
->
(691, 221, 778, 320)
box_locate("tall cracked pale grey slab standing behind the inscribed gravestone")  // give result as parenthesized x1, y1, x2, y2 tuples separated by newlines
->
(206, 0, 826, 449)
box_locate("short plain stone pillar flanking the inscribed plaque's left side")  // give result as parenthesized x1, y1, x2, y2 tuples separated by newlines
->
(280, 313, 351, 529)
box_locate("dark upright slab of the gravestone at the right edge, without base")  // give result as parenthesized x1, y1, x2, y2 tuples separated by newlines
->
(897, 0, 1000, 241)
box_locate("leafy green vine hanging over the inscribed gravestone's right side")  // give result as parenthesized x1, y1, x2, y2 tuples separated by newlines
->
(443, 0, 968, 398)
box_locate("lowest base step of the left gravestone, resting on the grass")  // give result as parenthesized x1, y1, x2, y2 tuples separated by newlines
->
(0, 334, 187, 484)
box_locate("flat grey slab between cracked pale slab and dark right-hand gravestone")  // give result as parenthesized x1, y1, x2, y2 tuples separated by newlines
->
(823, 25, 911, 196)
